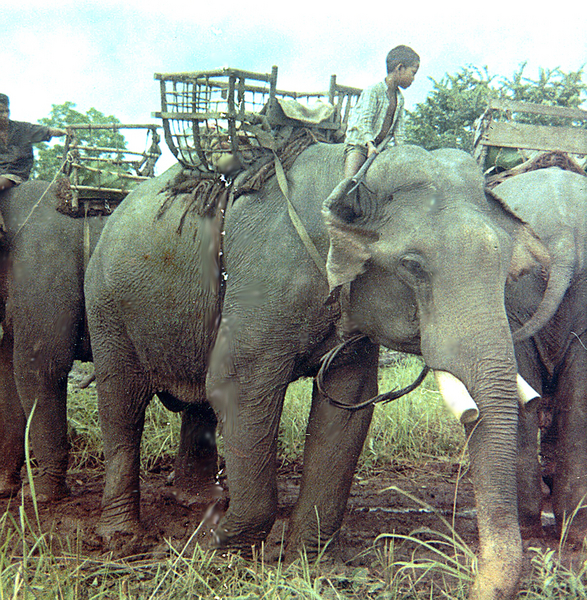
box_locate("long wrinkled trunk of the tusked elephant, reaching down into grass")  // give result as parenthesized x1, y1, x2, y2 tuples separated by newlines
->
(421, 296, 522, 600)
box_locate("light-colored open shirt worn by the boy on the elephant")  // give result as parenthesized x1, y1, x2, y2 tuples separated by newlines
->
(345, 81, 405, 146)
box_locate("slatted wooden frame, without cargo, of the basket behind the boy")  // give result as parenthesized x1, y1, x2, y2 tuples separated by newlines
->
(153, 66, 362, 174)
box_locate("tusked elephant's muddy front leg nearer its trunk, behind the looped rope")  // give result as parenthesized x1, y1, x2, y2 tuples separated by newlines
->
(286, 341, 379, 559)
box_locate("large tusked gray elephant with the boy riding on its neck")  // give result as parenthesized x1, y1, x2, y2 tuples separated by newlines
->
(85, 144, 548, 599)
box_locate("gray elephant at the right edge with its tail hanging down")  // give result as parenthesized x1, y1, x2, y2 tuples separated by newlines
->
(494, 167, 587, 542)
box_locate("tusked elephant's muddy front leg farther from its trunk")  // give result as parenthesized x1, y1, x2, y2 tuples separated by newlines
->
(206, 334, 293, 552)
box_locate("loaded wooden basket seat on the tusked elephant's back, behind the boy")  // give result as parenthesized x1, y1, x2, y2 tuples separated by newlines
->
(153, 66, 361, 176)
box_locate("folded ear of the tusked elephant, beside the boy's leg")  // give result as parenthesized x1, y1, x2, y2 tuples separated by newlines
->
(322, 186, 379, 292)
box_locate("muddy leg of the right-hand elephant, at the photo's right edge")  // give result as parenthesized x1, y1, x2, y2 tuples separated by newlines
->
(551, 336, 587, 544)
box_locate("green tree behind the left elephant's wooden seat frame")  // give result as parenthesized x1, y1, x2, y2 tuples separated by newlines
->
(32, 102, 126, 181)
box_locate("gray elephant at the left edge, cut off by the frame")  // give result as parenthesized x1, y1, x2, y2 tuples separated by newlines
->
(0, 181, 105, 500)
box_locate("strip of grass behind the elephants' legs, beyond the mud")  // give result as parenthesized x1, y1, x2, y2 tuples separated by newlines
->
(68, 356, 464, 478)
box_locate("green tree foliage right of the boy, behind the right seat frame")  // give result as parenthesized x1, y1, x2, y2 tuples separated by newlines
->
(406, 64, 587, 152)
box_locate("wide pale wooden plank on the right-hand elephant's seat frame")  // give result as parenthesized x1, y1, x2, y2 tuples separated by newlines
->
(481, 122, 587, 154)
